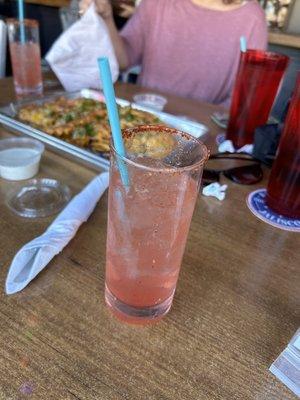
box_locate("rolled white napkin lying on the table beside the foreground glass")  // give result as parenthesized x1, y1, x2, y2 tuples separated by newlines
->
(5, 172, 109, 294)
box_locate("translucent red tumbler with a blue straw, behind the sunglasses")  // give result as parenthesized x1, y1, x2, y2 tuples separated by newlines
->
(226, 50, 289, 148)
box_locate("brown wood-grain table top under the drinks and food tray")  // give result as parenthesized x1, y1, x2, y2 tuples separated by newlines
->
(0, 76, 299, 400)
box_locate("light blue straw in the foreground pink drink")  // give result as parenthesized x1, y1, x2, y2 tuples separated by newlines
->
(98, 57, 129, 186)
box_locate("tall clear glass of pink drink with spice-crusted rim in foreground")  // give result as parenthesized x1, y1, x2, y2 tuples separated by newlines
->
(105, 125, 208, 324)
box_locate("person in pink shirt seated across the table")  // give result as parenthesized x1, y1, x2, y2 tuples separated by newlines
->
(81, 0, 267, 107)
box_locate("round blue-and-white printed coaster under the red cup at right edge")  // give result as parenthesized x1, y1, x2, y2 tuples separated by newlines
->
(247, 189, 300, 232)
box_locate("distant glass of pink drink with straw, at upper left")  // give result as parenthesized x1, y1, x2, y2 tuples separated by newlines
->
(7, 19, 43, 96)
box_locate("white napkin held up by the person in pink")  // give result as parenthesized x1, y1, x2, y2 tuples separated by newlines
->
(46, 3, 119, 91)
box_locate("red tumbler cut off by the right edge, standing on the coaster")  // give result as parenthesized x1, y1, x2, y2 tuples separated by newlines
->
(266, 74, 300, 218)
